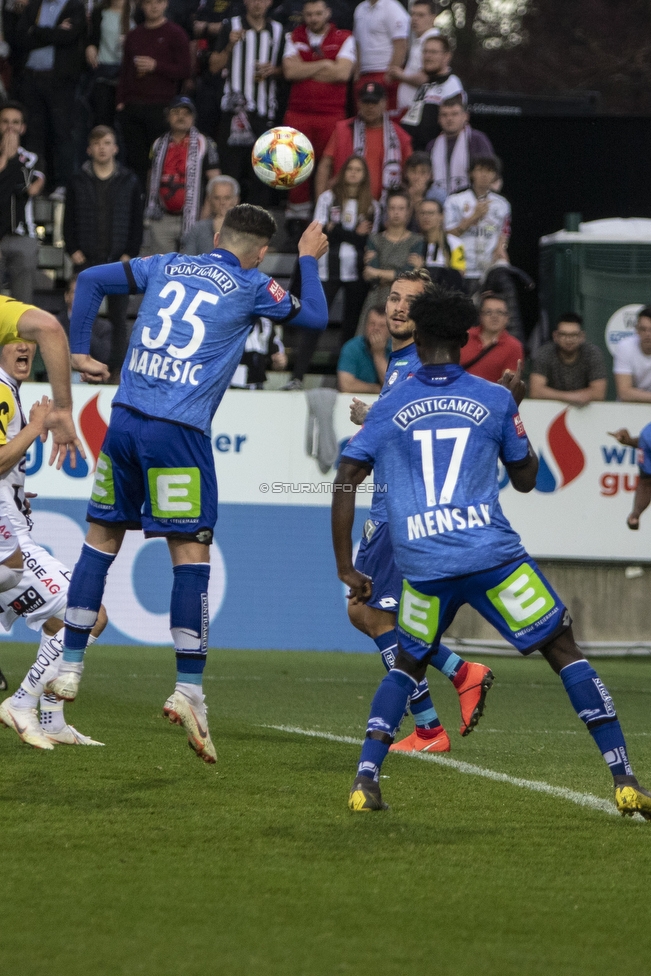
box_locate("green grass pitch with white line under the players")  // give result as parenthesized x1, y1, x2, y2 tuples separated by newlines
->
(0, 644, 651, 976)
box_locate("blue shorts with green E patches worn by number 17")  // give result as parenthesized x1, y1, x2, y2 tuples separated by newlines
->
(398, 555, 572, 661)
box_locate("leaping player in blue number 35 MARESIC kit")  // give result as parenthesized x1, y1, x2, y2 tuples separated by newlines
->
(48, 204, 328, 763)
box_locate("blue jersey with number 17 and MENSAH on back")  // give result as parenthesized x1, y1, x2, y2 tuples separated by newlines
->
(342, 365, 529, 581)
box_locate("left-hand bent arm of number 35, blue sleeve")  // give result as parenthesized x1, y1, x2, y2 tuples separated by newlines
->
(70, 261, 139, 383)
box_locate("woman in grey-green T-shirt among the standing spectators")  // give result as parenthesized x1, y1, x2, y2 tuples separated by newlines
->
(359, 187, 425, 323)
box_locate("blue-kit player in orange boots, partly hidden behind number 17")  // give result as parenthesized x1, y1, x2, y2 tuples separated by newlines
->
(348, 269, 493, 752)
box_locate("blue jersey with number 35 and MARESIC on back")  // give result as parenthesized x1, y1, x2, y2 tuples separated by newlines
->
(114, 250, 301, 434)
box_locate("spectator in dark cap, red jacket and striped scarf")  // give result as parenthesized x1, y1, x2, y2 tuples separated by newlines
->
(314, 81, 411, 200)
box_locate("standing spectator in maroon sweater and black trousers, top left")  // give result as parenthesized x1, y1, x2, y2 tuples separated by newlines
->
(116, 0, 191, 190)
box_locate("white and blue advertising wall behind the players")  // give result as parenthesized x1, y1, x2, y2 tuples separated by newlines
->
(3, 384, 651, 651)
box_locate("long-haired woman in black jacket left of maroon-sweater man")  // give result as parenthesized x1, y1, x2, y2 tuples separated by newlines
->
(86, 0, 133, 128)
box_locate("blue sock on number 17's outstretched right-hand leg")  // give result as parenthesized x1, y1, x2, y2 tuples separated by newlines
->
(560, 660, 633, 776)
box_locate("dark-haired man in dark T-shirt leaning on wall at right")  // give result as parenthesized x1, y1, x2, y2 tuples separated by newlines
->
(529, 312, 606, 407)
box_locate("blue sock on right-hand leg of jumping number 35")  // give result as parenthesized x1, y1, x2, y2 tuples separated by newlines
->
(170, 563, 210, 686)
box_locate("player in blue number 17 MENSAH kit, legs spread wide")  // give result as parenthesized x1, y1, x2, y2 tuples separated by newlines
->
(333, 289, 651, 820)
